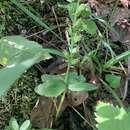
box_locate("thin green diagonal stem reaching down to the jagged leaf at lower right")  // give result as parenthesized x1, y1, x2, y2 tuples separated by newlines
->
(100, 79, 125, 109)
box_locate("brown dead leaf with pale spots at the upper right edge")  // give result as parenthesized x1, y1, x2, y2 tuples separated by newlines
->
(110, 8, 130, 44)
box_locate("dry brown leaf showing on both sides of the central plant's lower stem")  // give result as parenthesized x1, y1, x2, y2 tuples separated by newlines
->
(31, 91, 88, 128)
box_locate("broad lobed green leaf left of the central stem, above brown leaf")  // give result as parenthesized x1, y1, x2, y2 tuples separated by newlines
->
(35, 74, 66, 97)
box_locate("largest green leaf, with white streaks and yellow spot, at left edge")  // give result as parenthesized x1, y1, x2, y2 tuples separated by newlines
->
(0, 36, 50, 96)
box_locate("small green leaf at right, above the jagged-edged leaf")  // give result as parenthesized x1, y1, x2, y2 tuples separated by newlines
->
(105, 74, 121, 88)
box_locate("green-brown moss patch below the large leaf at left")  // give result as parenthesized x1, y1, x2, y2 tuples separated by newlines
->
(0, 68, 39, 129)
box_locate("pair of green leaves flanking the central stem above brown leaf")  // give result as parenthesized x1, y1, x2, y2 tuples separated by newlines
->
(35, 72, 96, 97)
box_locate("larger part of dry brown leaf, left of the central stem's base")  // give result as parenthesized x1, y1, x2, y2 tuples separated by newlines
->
(31, 96, 55, 128)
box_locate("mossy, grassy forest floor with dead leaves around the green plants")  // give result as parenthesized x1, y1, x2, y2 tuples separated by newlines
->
(0, 0, 130, 130)
